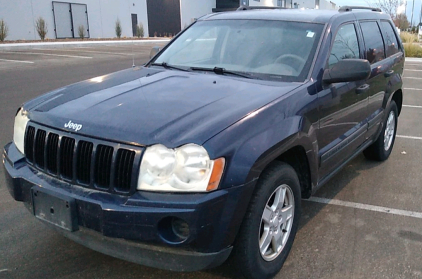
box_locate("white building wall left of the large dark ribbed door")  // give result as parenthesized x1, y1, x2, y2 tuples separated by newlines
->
(0, 0, 149, 40)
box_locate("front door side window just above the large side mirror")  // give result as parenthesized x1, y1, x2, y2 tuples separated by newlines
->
(328, 23, 359, 68)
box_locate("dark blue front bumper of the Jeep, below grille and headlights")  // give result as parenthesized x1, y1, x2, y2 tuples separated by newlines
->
(3, 143, 254, 271)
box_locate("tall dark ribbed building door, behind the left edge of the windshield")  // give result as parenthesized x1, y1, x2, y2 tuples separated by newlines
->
(147, 0, 181, 37)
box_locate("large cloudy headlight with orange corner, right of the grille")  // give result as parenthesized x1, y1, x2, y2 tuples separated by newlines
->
(137, 144, 225, 192)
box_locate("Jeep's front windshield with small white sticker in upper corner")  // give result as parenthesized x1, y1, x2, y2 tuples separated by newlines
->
(152, 20, 323, 81)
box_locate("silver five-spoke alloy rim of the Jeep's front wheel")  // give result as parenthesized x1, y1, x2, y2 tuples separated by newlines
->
(259, 184, 295, 261)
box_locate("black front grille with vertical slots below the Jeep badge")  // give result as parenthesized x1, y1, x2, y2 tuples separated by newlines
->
(25, 124, 142, 194)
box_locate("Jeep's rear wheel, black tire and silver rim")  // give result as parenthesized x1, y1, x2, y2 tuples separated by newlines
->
(363, 101, 398, 161)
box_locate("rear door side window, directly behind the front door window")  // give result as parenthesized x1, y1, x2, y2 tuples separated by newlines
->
(360, 21, 385, 64)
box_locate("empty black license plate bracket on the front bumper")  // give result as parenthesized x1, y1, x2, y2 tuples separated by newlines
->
(31, 187, 79, 232)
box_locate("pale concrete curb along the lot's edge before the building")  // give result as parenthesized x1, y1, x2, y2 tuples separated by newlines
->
(0, 39, 170, 51)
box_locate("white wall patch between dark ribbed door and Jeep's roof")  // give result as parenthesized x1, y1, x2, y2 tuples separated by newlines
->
(180, 0, 216, 29)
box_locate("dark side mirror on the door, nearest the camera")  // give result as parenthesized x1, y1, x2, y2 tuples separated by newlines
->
(322, 59, 371, 83)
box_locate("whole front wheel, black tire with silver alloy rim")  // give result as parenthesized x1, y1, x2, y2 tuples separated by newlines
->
(232, 162, 301, 279)
